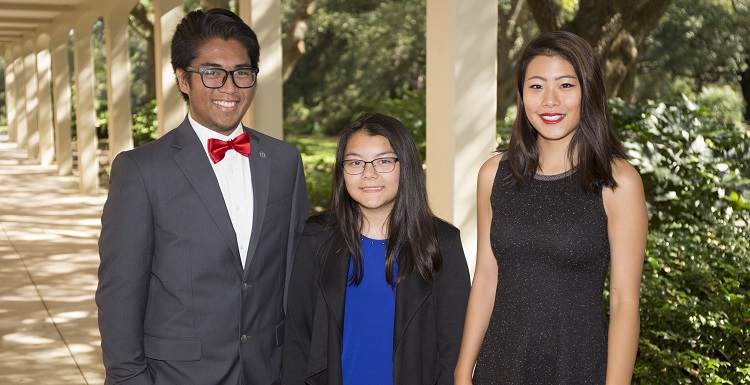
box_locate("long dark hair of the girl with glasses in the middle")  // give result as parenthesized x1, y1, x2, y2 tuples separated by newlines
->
(326, 113, 442, 287)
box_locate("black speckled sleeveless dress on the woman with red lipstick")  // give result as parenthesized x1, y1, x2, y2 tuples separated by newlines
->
(474, 159, 610, 385)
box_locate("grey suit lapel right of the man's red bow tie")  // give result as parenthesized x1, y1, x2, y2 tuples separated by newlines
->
(243, 126, 271, 271)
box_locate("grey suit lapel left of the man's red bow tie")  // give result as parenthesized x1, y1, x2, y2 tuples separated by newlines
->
(173, 119, 242, 267)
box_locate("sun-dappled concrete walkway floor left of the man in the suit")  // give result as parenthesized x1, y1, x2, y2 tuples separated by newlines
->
(0, 133, 106, 385)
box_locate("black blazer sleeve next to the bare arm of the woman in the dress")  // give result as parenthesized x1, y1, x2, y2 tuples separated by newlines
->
(435, 225, 471, 385)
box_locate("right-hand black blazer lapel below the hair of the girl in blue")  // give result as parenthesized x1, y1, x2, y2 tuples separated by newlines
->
(393, 270, 432, 352)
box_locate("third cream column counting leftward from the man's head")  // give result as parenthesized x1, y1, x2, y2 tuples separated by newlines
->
(73, 16, 99, 194)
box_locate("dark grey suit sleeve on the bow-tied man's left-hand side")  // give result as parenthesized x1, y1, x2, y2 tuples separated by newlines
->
(96, 153, 154, 385)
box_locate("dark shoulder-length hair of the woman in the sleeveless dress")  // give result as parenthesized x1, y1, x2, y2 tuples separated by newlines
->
(505, 31, 627, 191)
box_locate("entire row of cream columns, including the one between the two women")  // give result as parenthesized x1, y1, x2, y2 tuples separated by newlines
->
(5, 0, 497, 259)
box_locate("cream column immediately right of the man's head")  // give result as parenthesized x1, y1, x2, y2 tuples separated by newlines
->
(248, 0, 284, 139)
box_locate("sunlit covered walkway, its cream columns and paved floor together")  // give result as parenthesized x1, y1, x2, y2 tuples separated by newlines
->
(0, 0, 497, 385)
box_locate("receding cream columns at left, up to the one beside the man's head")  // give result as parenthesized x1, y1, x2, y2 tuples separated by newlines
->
(2, 0, 282, 194)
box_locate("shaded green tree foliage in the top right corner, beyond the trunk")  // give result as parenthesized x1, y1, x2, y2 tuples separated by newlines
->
(638, 0, 750, 100)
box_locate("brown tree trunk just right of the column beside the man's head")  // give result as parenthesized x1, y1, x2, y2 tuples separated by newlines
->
(281, 0, 317, 81)
